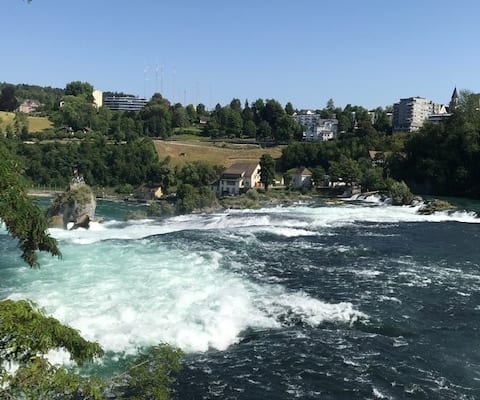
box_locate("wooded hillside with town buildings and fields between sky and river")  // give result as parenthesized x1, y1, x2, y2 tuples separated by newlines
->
(0, 81, 480, 208)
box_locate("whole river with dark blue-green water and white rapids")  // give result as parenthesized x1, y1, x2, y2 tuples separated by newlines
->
(0, 201, 480, 400)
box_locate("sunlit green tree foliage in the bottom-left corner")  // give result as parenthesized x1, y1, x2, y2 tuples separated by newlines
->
(0, 300, 103, 400)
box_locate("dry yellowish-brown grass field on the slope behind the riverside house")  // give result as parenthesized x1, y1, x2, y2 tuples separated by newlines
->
(154, 140, 284, 167)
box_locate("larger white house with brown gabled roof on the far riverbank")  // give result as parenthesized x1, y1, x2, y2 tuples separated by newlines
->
(217, 161, 261, 195)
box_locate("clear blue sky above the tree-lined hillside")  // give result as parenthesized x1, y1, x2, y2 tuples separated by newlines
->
(0, 0, 480, 108)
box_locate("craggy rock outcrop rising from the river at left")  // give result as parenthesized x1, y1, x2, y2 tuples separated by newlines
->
(47, 183, 97, 229)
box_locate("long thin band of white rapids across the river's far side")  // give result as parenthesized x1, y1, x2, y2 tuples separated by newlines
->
(50, 203, 480, 245)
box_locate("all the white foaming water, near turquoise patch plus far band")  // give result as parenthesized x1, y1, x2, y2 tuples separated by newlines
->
(2, 204, 478, 353)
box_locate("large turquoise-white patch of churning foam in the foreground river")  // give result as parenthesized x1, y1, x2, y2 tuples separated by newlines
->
(9, 242, 364, 354)
